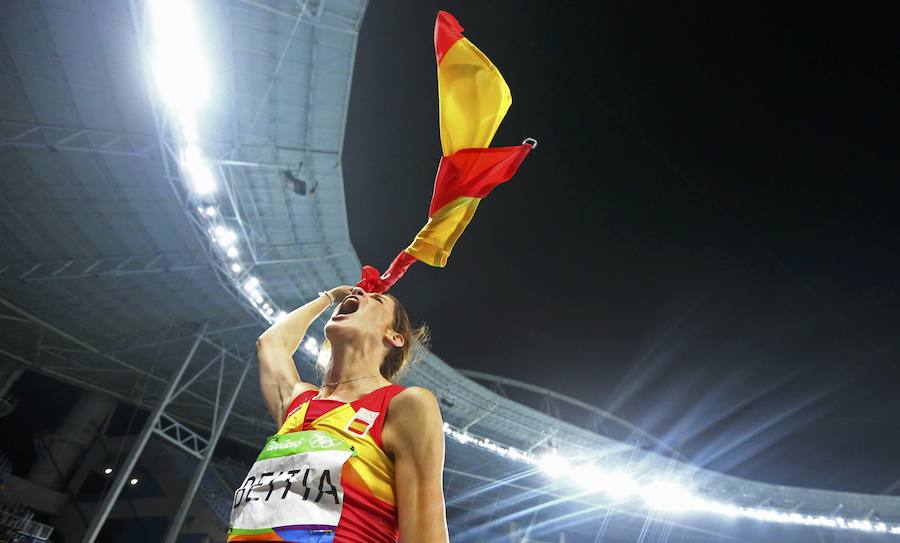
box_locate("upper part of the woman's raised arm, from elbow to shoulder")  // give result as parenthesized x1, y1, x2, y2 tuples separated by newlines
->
(256, 340, 316, 426)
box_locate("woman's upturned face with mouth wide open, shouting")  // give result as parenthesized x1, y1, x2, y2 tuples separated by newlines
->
(325, 287, 395, 343)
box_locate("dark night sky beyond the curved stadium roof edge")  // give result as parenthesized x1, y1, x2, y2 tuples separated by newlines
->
(344, 0, 900, 493)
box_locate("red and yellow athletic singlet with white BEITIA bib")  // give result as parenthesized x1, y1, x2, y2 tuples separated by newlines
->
(228, 384, 404, 543)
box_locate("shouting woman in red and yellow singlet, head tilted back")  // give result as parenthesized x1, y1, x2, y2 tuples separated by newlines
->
(228, 286, 448, 543)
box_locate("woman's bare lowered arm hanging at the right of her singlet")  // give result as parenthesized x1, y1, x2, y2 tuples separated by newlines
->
(382, 387, 449, 543)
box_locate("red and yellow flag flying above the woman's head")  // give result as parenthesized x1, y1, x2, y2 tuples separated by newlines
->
(357, 11, 537, 292)
